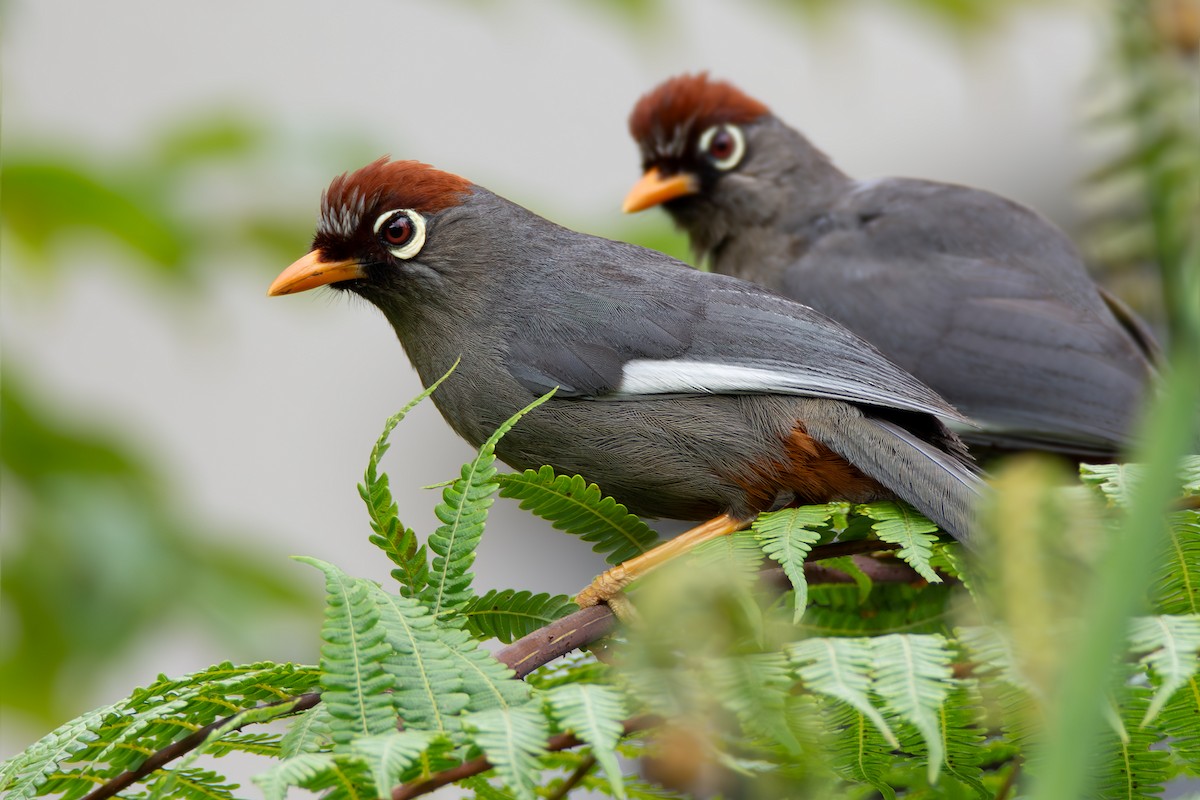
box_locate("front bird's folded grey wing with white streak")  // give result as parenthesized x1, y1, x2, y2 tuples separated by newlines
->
(506, 243, 965, 421)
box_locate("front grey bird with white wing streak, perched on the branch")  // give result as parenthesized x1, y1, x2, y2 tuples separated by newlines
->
(268, 156, 985, 606)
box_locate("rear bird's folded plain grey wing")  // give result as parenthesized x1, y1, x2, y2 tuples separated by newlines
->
(782, 180, 1151, 450)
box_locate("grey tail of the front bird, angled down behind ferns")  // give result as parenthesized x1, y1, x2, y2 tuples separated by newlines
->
(805, 403, 986, 545)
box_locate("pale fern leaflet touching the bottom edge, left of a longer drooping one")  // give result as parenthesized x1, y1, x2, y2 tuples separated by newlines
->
(463, 706, 550, 800)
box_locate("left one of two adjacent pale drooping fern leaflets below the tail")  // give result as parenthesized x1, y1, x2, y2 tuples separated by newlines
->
(786, 638, 900, 747)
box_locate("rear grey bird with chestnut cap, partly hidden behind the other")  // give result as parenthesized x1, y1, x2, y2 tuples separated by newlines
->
(624, 74, 1156, 457)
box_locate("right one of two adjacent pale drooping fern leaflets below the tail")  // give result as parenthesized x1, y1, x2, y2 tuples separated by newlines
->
(871, 633, 954, 783)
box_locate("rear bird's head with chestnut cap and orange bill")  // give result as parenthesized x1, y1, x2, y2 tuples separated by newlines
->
(624, 72, 770, 212)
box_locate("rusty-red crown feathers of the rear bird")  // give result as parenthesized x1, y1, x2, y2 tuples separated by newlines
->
(629, 72, 769, 142)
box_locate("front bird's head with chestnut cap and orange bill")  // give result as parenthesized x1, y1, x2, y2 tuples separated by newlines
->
(268, 157, 476, 300)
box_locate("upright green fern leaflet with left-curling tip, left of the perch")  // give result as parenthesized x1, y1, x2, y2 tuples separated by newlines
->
(296, 557, 396, 747)
